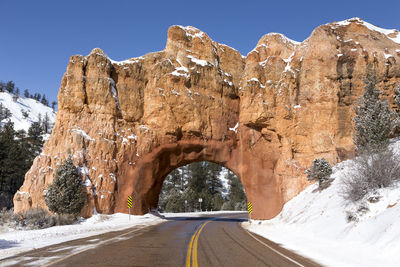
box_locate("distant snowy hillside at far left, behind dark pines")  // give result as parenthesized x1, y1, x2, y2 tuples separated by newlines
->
(0, 92, 56, 131)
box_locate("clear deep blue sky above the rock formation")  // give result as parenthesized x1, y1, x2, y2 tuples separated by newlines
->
(0, 0, 400, 104)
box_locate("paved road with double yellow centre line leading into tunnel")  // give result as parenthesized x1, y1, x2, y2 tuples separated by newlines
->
(0, 213, 320, 267)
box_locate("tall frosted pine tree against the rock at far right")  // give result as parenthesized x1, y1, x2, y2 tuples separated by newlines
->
(353, 67, 393, 154)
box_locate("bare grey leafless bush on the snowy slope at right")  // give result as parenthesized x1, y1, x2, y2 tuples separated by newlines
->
(342, 148, 400, 202)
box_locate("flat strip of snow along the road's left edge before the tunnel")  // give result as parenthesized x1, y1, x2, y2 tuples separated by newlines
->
(0, 213, 165, 259)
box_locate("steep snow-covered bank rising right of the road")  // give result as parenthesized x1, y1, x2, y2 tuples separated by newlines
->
(243, 141, 400, 267)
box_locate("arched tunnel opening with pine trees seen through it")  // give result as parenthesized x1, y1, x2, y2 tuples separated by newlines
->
(157, 161, 247, 213)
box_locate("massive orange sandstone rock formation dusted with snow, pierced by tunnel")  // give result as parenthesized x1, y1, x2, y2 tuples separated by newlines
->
(14, 18, 400, 219)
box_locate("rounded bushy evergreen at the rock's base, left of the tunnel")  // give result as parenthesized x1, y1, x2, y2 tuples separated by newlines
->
(45, 158, 85, 215)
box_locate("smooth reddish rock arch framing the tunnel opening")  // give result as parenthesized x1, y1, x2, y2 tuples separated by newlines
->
(116, 140, 283, 218)
